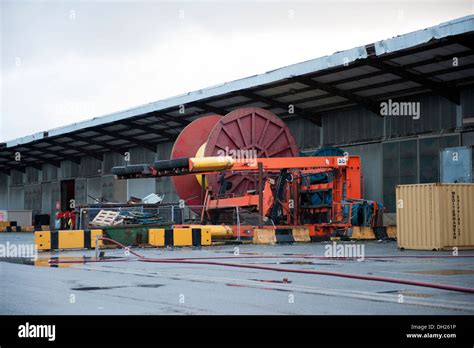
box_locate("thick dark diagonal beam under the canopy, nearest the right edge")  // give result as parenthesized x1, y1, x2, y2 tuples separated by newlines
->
(367, 58, 461, 105)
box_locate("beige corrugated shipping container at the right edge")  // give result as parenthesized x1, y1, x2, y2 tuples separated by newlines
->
(396, 184, 474, 250)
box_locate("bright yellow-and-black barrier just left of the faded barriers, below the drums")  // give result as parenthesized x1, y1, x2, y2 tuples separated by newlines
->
(148, 228, 211, 247)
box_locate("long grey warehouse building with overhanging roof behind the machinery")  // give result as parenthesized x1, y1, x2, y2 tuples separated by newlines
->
(0, 16, 474, 227)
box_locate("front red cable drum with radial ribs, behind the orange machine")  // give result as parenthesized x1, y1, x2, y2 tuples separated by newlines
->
(204, 107, 298, 194)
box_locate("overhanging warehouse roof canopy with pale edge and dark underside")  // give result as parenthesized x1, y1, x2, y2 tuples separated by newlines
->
(0, 15, 474, 172)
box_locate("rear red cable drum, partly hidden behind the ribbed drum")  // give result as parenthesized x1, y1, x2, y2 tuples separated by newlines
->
(171, 115, 222, 209)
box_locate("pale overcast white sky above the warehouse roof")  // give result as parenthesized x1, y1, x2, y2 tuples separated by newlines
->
(0, 0, 474, 141)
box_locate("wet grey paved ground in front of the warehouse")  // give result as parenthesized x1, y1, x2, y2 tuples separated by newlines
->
(0, 233, 474, 315)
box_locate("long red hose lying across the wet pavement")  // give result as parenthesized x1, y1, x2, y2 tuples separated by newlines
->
(50, 237, 474, 294)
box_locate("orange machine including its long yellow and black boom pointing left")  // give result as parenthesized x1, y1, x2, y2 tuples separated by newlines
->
(113, 156, 379, 237)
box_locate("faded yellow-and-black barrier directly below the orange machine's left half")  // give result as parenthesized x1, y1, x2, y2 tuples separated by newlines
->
(253, 226, 311, 244)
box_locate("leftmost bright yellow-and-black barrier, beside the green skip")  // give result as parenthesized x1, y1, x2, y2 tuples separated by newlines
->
(35, 230, 102, 250)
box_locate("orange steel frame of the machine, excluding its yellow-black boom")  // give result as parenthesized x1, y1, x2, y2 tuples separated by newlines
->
(195, 156, 362, 237)
